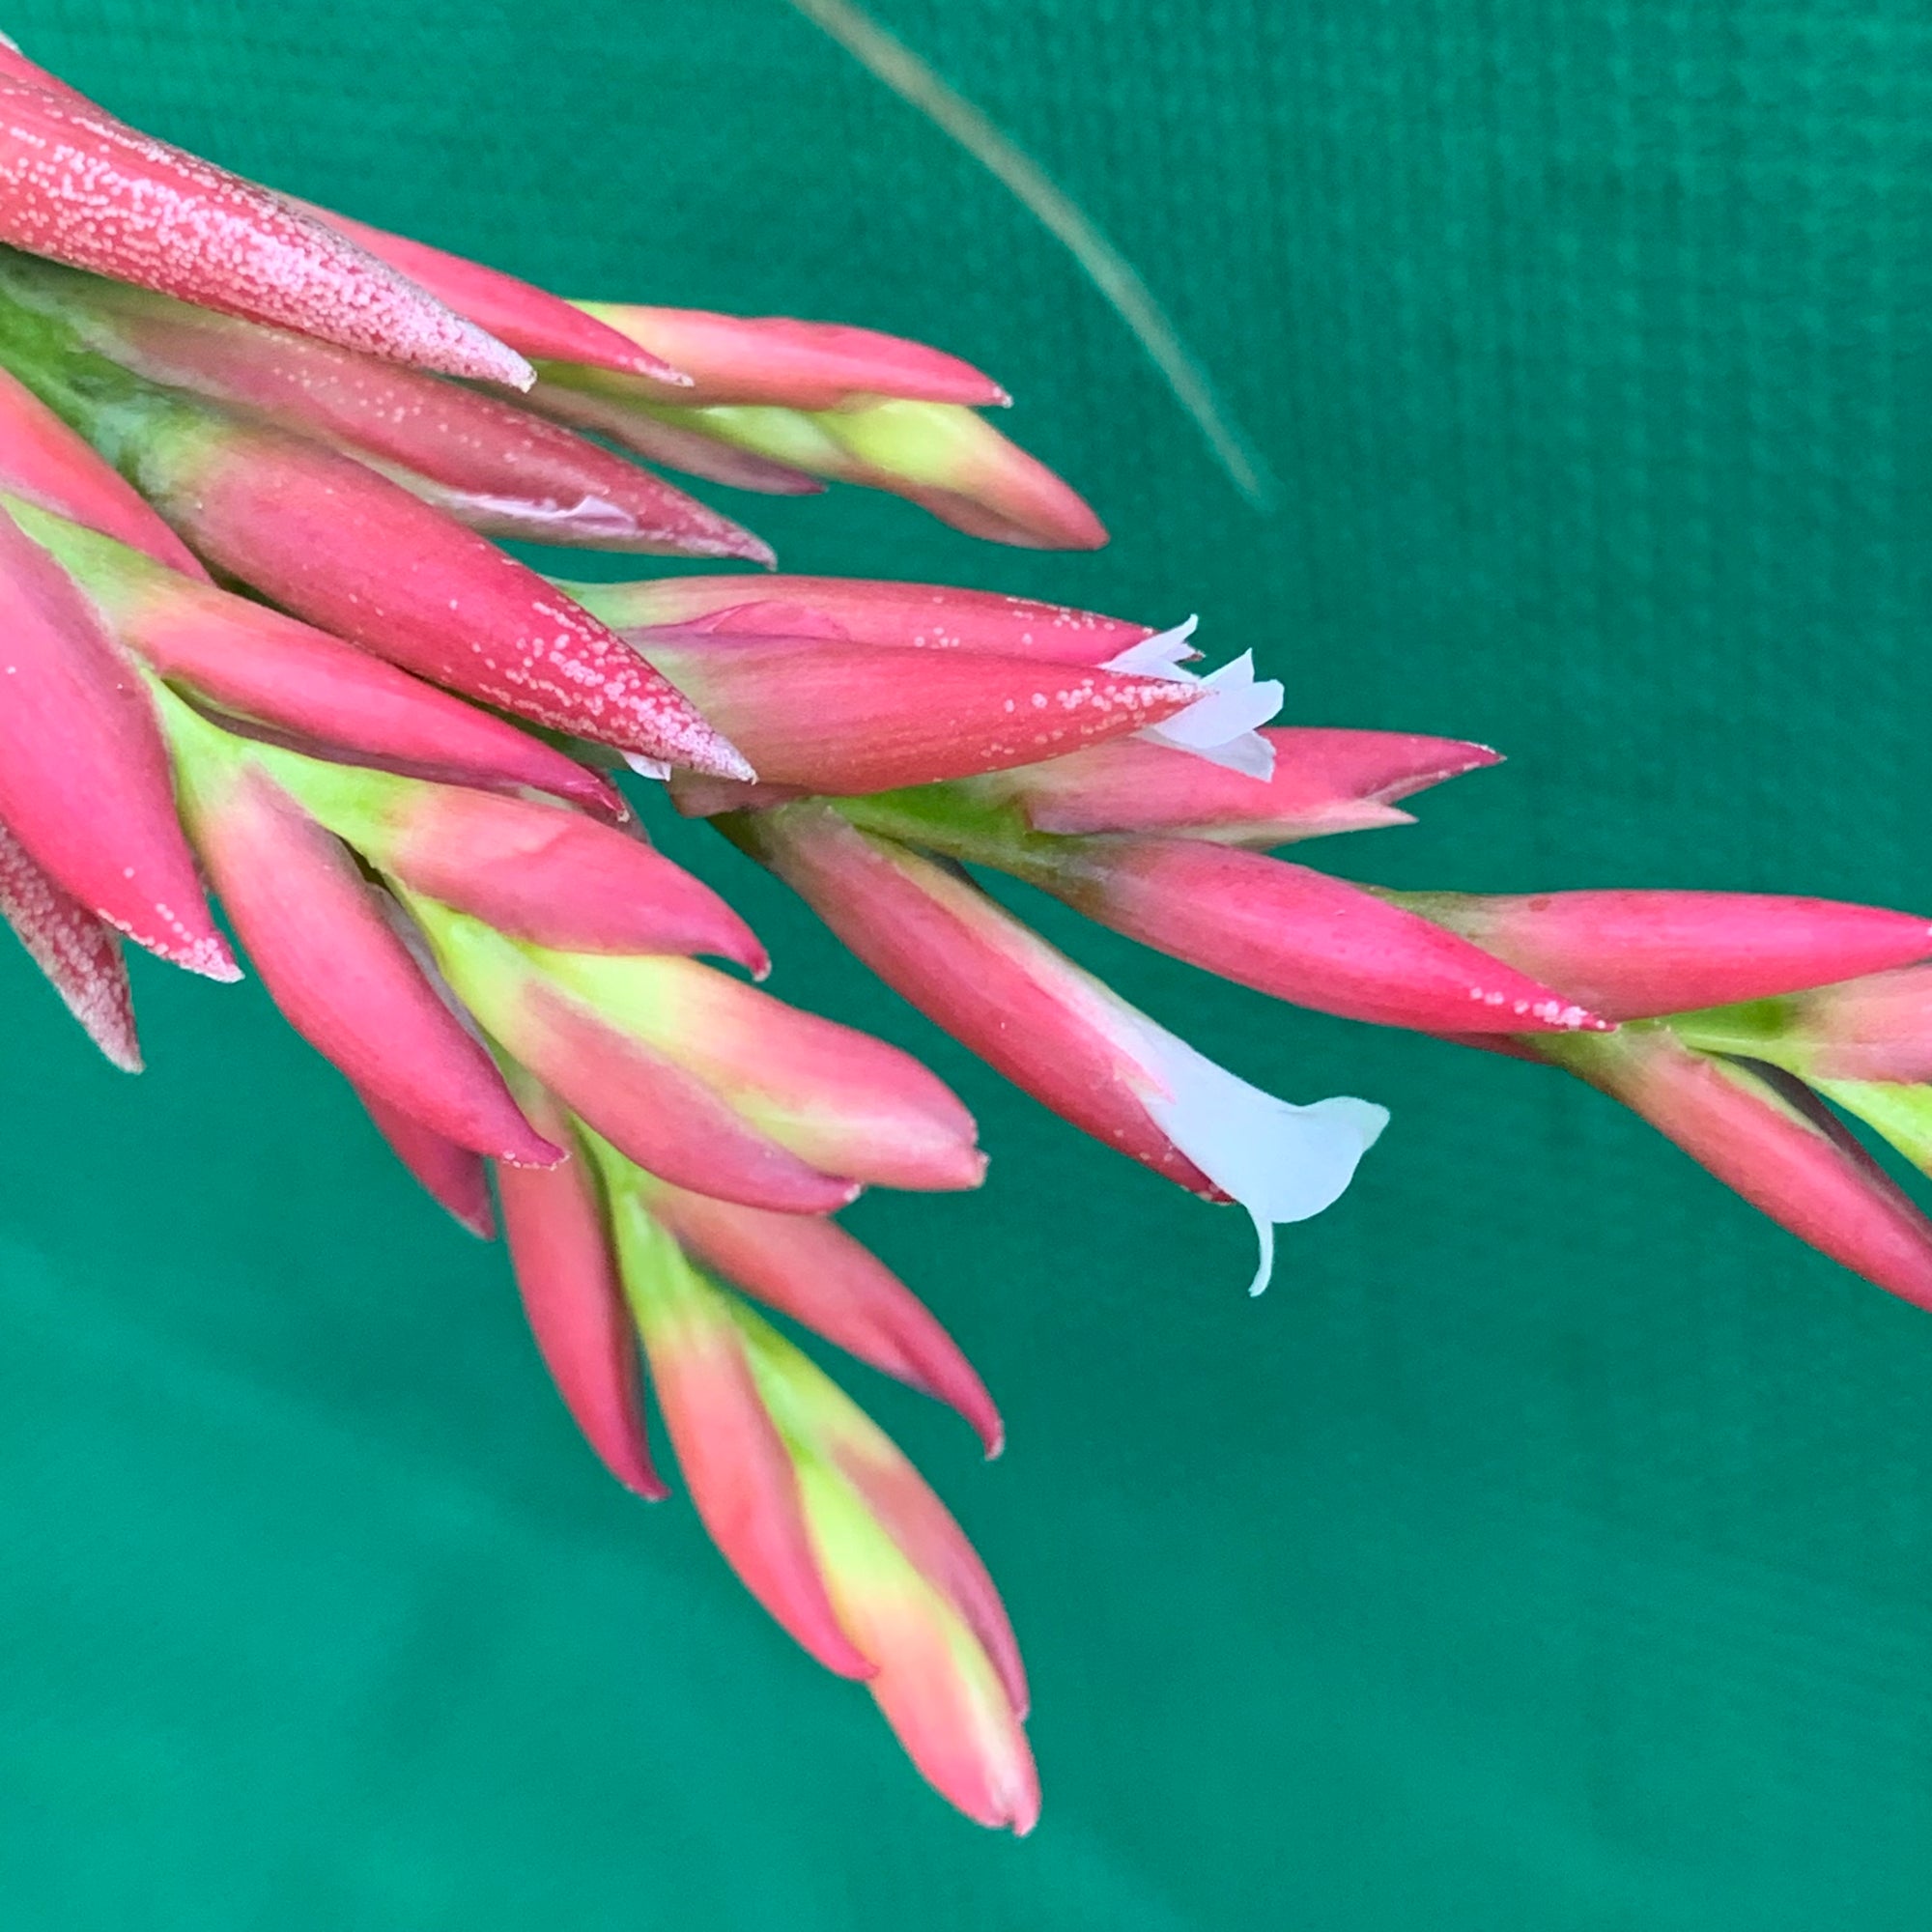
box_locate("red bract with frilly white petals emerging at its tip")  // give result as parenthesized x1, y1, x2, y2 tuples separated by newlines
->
(636, 632, 1200, 794)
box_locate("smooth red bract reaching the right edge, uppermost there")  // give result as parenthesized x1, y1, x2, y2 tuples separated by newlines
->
(1385, 891, 1932, 1020)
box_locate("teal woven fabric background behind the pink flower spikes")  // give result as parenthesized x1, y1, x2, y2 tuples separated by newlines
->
(0, 0, 1932, 1932)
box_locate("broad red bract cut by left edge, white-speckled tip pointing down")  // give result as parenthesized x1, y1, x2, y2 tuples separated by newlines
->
(0, 514, 236, 980)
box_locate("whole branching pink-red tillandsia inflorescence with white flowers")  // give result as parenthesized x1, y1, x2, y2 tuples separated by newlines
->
(11, 46, 1932, 1832)
